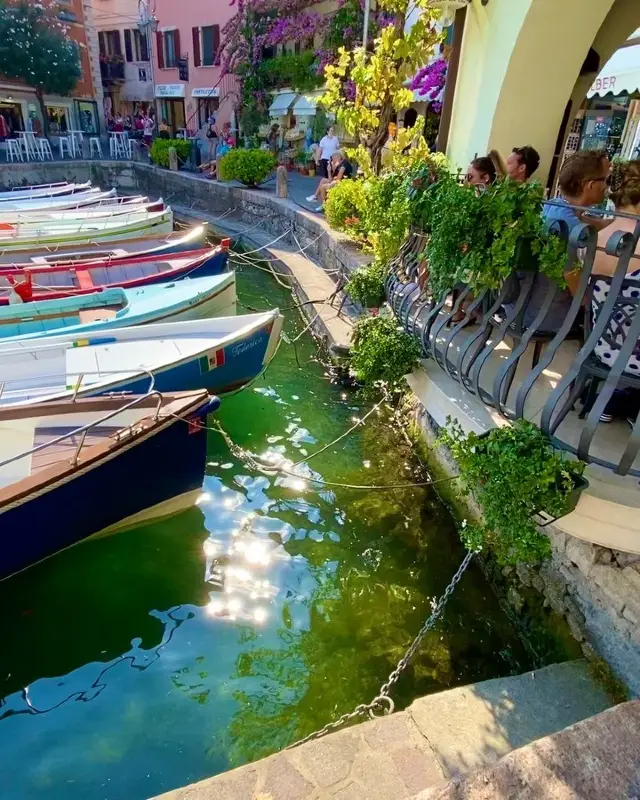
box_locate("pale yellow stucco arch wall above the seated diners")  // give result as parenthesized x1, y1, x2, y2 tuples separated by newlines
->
(447, 0, 640, 182)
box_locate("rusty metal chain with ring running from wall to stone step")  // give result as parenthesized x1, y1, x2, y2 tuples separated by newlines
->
(285, 550, 475, 750)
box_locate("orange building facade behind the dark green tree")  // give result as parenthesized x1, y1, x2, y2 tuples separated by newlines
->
(0, 0, 101, 135)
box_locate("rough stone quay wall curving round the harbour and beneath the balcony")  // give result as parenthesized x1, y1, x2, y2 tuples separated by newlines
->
(0, 161, 640, 696)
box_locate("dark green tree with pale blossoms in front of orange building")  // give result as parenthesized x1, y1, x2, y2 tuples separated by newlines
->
(0, 0, 81, 130)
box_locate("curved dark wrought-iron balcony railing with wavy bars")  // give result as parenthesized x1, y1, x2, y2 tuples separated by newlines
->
(387, 209, 640, 476)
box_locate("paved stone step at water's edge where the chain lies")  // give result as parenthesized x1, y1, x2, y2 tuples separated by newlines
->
(154, 661, 609, 800)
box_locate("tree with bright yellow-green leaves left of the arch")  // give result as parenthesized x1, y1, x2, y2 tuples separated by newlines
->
(321, 0, 442, 172)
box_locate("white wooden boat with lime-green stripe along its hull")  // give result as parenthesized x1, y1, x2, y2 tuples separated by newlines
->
(0, 209, 173, 252)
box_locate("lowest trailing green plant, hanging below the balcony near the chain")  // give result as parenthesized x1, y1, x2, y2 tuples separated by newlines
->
(439, 420, 585, 565)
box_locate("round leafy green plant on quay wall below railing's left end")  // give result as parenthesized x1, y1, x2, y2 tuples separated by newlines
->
(351, 316, 420, 390)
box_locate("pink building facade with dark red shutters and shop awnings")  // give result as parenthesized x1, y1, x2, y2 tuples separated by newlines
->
(152, 0, 237, 134)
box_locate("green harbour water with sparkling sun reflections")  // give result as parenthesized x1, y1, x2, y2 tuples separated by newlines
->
(0, 255, 563, 800)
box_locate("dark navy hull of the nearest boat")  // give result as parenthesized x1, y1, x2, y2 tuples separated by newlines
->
(0, 399, 218, 579)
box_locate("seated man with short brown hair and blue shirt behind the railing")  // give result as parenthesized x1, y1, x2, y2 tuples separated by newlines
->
(504, 150, 611, 333)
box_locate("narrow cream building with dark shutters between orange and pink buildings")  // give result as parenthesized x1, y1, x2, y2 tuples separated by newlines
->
(91, 0, 154, 119)
